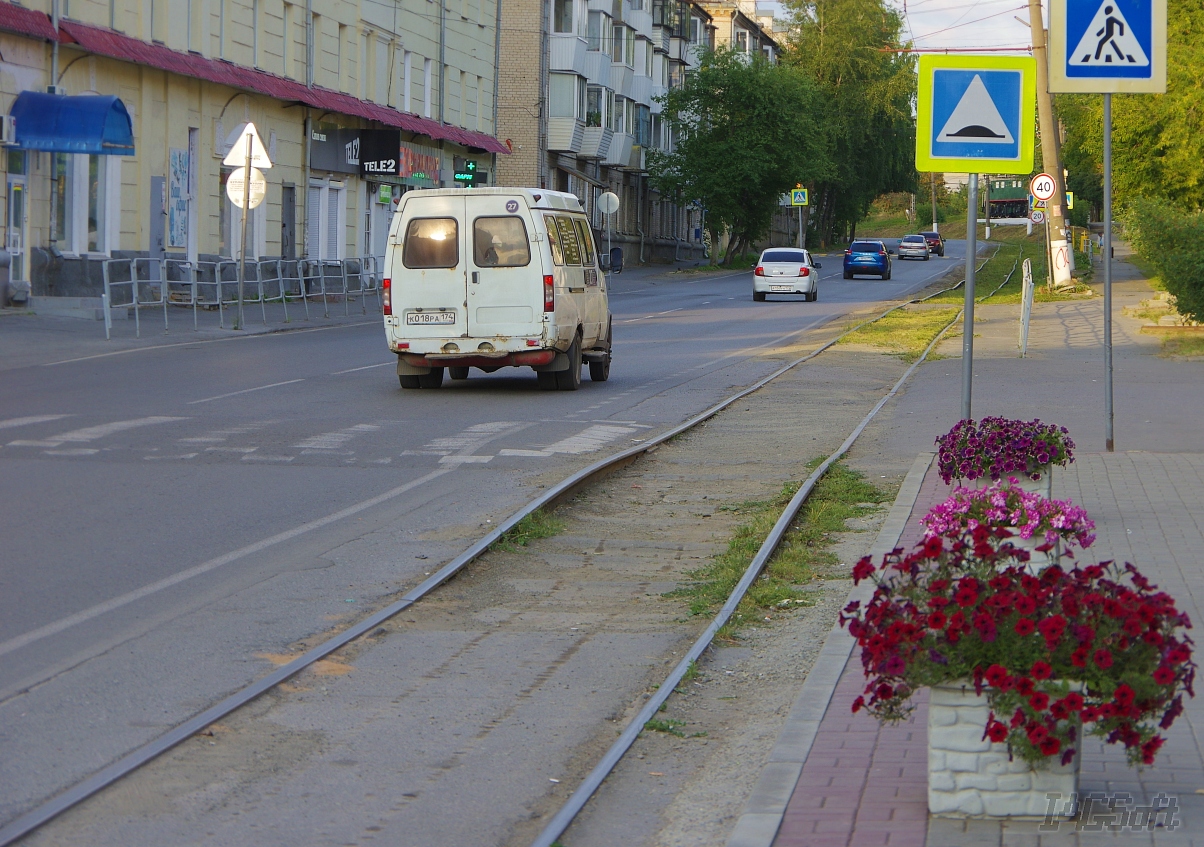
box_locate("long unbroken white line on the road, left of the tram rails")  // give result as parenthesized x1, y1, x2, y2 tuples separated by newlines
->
(0, 465, 455, 655)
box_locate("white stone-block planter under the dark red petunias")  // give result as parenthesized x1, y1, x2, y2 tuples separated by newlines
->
(928, 682, 1080, 818)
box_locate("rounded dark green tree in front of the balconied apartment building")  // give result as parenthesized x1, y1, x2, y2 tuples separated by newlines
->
(648, 48, 828, 263)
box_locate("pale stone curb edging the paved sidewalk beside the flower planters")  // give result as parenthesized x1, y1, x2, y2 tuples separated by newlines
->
(727, 453, 937, 847)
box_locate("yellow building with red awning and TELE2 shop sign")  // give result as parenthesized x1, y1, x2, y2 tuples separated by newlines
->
(0, 0, 508, 295)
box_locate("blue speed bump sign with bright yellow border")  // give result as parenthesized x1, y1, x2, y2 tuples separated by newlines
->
(915, 54, 1037, 173)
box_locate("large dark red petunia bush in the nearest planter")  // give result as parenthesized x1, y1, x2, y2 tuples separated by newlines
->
(840, 532, 1196, 766)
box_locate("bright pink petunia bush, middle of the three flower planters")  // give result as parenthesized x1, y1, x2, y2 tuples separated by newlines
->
(920, 477, 1096, 549)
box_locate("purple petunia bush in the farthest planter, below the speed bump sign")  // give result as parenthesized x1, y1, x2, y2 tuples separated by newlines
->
(937, 418, 1074, 483)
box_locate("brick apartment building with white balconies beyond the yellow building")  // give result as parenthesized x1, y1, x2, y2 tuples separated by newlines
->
(497, 0, 736, 261)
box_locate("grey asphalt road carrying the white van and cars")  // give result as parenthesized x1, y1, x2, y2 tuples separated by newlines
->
(0, 242, 962, 824)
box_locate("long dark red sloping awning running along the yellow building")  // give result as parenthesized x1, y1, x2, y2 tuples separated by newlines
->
(55, 19, 509, 153)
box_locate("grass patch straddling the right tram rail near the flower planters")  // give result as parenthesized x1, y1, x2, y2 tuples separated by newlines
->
(668, 459, 887, 641)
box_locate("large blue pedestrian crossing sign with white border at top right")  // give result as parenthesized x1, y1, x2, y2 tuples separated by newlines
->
(1050, 0, 1167, 94)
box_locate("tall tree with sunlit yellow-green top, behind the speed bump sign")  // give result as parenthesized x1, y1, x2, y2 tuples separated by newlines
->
(784, 0, 915, 242)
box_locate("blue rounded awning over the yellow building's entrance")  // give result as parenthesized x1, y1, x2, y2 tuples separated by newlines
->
(11, 92, 134, 155)
